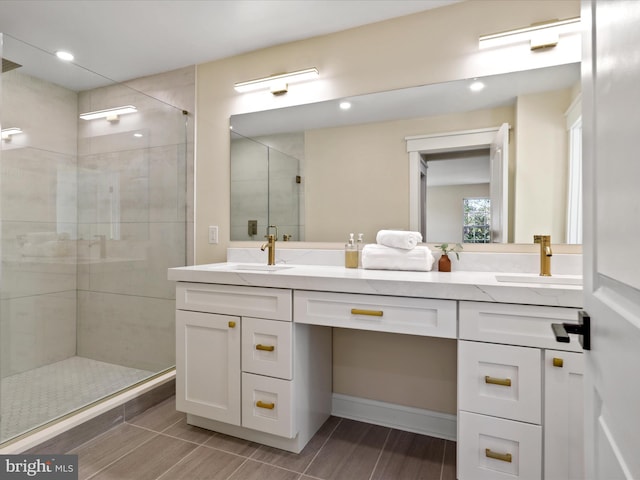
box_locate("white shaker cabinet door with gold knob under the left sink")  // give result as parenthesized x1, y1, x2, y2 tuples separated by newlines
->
(176, 310, 241, 425)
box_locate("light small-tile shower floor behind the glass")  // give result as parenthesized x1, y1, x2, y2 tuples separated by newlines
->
(0, 357, 156, 442)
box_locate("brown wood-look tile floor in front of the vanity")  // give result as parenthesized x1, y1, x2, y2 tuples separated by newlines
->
(46, 397, 456, 480)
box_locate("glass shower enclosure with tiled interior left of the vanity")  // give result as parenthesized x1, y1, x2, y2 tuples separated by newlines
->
(0, 34, 192, 444)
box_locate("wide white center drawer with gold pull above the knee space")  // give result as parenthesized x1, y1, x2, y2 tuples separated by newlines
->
(293, 290, 457, 338)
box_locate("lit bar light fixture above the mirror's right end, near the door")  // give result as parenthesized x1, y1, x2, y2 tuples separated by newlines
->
(479, 17, 580, 50)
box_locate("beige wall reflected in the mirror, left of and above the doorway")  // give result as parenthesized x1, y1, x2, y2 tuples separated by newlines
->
(305, 107, 515, 242)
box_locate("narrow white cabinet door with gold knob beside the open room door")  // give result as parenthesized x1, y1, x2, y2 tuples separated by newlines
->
(544, 350, 585, 480)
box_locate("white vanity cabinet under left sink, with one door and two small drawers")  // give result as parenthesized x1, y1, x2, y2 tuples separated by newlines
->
(176, 282, 331, 453)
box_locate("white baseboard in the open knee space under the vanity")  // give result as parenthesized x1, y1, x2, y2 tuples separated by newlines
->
(331, 393, 457, 442)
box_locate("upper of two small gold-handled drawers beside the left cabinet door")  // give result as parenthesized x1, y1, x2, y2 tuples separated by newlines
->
(242, 317, 293, 380)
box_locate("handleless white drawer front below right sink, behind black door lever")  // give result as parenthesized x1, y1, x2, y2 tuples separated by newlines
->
(459, 302, 582, 352)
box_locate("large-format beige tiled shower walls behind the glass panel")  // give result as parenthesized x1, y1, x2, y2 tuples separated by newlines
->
(0, 63, 195, 377)
